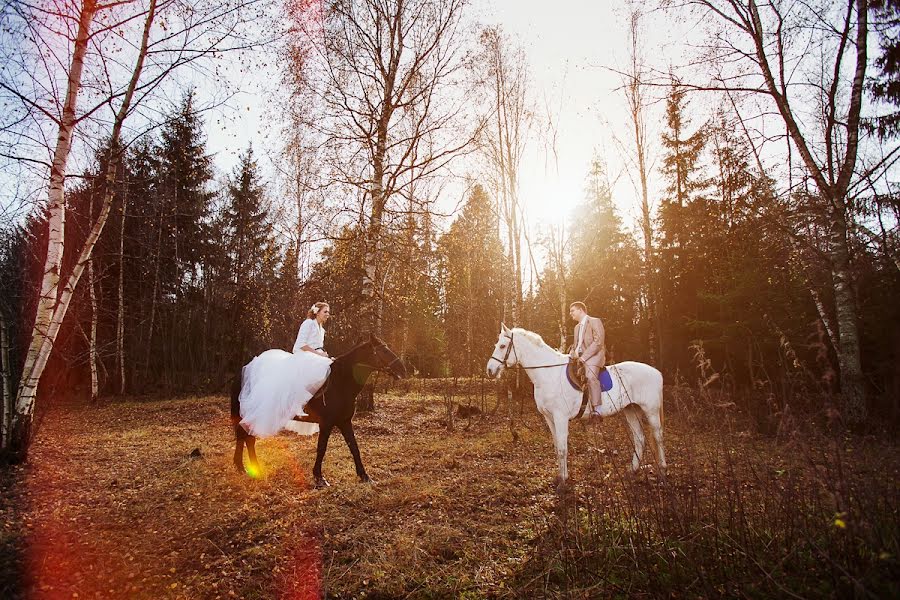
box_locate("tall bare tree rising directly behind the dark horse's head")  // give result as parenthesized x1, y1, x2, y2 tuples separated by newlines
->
(291, 0, 470, 332)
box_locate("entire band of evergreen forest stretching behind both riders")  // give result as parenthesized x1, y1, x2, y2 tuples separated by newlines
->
(2, 87, 900, 422)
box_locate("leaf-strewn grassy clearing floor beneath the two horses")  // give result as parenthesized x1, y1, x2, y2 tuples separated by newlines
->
(0, 386, 900, 599)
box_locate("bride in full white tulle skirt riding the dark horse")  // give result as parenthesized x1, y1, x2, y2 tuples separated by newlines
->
(240, 302, 332, 437)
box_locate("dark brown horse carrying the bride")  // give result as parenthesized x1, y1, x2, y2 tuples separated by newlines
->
(231, 335, 406, 488)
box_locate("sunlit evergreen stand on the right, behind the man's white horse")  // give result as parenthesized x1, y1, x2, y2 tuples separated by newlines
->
(531, 95, 900, 417)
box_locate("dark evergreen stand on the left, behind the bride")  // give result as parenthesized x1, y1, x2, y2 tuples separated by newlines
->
(2, 95, 300, 396)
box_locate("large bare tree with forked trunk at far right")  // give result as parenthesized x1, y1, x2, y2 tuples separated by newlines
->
(672, 0, 897, 423)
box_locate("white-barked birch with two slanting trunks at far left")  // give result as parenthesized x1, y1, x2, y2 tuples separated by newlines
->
(0, 0, 272, 459)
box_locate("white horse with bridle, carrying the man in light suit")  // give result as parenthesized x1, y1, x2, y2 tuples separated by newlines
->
(487, 324, 666, 485)
